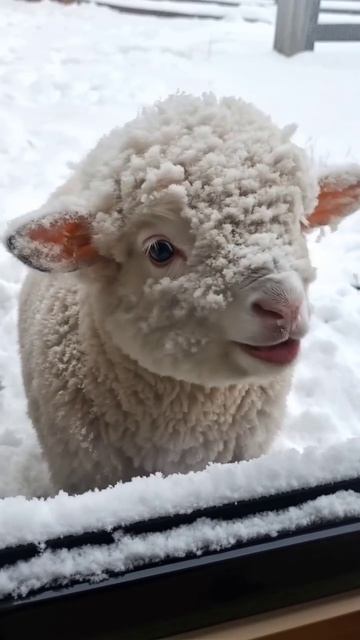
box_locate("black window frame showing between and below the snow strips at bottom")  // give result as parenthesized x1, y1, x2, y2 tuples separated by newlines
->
(0, 477, 360, 640)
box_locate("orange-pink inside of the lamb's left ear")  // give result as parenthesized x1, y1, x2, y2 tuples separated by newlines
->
(28, 217, 99, 264)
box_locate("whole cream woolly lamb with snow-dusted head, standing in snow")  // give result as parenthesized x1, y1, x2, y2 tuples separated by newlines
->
(6, 94, 360, 493)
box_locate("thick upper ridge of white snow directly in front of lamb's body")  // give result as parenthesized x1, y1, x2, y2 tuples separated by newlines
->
(0, 438, 360, 549)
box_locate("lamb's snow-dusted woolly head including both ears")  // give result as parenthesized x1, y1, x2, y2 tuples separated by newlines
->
(8, 95, 360, 385)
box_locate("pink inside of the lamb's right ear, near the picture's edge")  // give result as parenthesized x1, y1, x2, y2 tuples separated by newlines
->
(308, 183, 360, 227)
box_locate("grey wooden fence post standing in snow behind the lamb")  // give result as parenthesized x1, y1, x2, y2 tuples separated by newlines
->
(274, 0, 320, 56)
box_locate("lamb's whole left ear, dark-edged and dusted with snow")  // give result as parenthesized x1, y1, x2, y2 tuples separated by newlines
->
(6, 212, 101, 271)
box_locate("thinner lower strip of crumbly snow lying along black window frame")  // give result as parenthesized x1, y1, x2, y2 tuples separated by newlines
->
(0, 491, 360, 598)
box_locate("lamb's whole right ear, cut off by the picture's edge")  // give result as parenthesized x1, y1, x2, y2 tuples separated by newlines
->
(307, 166, 360, 229)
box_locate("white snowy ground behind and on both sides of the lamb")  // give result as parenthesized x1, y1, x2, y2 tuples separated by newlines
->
(0, 0, 360, 496)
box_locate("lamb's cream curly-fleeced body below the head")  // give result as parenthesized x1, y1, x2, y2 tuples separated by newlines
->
(20, 274, 289, 491)
